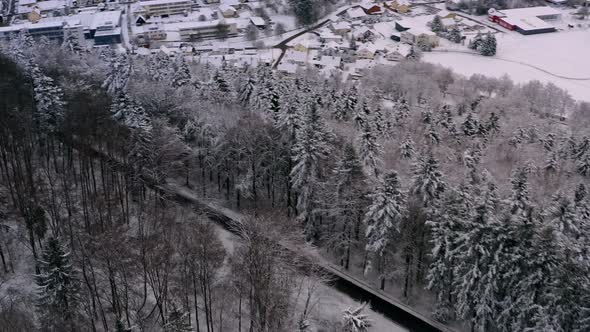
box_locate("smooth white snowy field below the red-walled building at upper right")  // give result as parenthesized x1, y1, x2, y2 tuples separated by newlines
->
(424, 30, 590, 101)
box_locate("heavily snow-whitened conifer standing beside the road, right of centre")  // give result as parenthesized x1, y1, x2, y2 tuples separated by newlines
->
(363, 171, 407, 289)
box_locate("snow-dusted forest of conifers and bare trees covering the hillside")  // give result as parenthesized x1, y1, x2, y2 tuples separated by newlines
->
(0, 35, 590, 332)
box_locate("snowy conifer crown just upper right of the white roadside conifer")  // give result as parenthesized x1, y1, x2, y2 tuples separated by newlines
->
(412, 154, 446, 206)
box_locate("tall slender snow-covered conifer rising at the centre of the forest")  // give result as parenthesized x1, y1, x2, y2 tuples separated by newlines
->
(291, 104, 332, 235)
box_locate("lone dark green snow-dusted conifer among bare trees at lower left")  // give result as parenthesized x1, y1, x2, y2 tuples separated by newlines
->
(35, 238, 78, 331)
